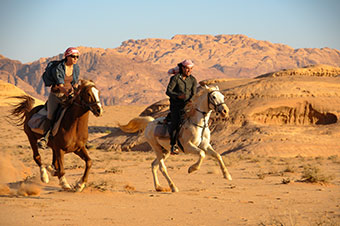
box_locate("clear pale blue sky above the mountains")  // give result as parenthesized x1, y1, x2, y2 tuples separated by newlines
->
(0, 0, 340, 63)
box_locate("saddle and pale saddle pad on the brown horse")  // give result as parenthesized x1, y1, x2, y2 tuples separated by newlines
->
(27, 105, 67, 136)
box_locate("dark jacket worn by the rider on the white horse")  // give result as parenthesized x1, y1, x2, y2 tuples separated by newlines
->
(166, 73, 197, 108)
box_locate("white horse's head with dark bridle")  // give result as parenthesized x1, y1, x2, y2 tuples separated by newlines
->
(205, 86, 229, 118)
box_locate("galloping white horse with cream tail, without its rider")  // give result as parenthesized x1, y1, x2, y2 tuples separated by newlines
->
(119, 86, 232, 192)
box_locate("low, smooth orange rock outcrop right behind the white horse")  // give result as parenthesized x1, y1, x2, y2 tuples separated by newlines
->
(94, 69, 340, 156)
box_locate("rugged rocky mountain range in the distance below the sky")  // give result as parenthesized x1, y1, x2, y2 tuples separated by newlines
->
(0, 35, 340, 105)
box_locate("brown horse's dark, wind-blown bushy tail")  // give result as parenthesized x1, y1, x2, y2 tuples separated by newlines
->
(10, 95, 35, 126)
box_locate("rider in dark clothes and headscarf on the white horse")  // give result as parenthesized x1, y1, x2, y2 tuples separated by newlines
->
(166, 60, 197, 154)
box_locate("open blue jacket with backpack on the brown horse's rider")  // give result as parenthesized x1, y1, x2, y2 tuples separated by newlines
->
(47, 60, 80, 86)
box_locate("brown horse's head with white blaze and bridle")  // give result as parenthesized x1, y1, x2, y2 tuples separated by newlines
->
(78, 80, 103, 117)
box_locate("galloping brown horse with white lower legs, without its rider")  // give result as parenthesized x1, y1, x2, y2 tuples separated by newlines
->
(11, 80, 103, 191)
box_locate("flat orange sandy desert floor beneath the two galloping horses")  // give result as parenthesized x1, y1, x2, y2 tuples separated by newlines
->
(0, 106, 340, 226)
